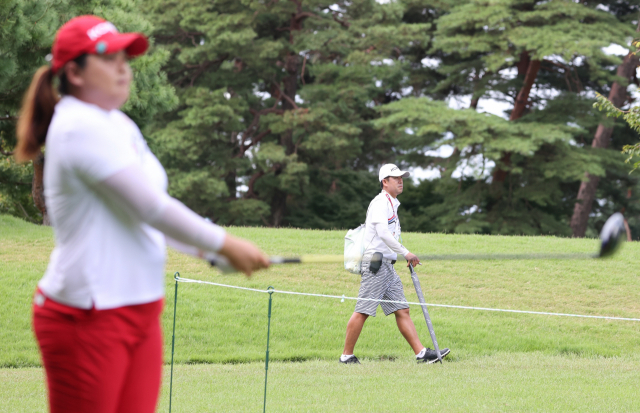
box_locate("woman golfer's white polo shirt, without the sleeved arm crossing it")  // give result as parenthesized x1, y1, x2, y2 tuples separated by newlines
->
(38, 96, 167, 309)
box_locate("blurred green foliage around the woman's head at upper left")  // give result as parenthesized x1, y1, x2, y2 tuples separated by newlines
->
(0, 0, 177, 222)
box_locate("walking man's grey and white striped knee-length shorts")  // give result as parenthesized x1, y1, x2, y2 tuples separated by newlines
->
(355, 260, 409, 317)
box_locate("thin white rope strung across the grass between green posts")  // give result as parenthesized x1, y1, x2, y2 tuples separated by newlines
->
(174, 276, 640, 321)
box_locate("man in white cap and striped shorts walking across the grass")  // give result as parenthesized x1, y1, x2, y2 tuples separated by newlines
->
(340, 164, 450, 364)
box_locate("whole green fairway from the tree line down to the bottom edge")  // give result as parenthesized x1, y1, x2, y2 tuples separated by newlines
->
(0, 217, 640, 412)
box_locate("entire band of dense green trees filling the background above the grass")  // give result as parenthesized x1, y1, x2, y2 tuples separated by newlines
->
(0, 0, 640, 236)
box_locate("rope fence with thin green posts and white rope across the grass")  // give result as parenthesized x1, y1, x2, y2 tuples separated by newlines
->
(169, 272, 640, 413)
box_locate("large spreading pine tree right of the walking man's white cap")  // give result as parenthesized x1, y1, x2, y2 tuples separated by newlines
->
(377, 1, 633, 235)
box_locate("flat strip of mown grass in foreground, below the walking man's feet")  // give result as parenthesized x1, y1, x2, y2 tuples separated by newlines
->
(0, 352, 640, 413)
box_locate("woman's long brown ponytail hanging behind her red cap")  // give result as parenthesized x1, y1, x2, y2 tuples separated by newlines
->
(14, 66, 59, 162)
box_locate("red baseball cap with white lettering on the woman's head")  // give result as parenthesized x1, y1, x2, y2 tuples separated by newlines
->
(51, 16, 149, 73)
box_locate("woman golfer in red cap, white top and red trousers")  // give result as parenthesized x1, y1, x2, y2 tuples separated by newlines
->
(16, 16, 269, 413)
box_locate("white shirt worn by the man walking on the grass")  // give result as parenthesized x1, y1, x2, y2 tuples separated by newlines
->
(364, 190, 409, 260)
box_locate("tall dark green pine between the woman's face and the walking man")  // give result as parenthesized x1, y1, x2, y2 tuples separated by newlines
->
(149, 0, 430, 228)
